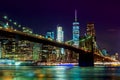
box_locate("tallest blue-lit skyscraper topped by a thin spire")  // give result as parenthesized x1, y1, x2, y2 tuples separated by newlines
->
(73, 10, 80, 47)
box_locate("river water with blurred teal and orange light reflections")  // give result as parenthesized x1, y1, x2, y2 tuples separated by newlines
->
(0, 66, 120, 80)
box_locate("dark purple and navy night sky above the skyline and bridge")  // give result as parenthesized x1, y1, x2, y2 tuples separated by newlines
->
(0, 0, 120, 54)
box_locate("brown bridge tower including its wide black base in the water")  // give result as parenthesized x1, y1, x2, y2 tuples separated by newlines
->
(79, 23, 96, 67)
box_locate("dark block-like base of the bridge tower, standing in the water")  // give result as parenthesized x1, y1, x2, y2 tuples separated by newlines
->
(78, 52, 94, 67)
